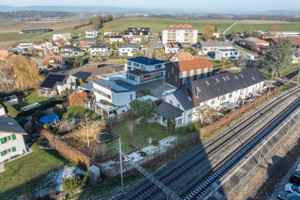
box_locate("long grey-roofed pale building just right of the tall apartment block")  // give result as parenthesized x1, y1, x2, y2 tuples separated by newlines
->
(197, 41, 232, 55)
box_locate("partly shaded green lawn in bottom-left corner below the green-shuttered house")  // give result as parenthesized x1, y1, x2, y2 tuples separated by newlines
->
(0, 144, 68, 200)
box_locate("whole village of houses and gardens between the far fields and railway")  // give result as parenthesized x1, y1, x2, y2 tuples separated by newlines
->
(0, 12, 300, 198)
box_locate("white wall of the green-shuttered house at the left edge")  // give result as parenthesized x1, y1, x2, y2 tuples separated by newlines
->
(0, 133, 26, 163)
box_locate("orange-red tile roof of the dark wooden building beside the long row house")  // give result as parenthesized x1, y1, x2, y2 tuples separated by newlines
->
(170, 58, 214, 71)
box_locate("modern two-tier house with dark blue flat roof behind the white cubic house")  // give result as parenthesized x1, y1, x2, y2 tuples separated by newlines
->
(125, 56, 166, 84)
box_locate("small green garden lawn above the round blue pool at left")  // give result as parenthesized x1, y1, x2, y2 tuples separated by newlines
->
(14, 91, 55, 109)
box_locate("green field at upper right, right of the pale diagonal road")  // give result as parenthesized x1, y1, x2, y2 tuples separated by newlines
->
(227, 20, 300, 33)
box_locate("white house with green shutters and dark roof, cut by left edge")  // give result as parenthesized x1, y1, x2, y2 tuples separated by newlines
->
(0, 116, 27, 164)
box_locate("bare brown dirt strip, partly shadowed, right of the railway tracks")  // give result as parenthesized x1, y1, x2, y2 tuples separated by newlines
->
(228, 124, 300, 200)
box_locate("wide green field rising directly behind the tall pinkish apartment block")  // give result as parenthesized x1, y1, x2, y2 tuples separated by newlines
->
(100, 18, 235, 33)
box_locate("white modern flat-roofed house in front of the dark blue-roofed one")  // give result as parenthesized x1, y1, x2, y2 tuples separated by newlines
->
(92, 80, 136, 118)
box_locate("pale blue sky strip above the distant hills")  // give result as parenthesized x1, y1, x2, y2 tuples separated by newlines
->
(0, 0, 300, 12)
